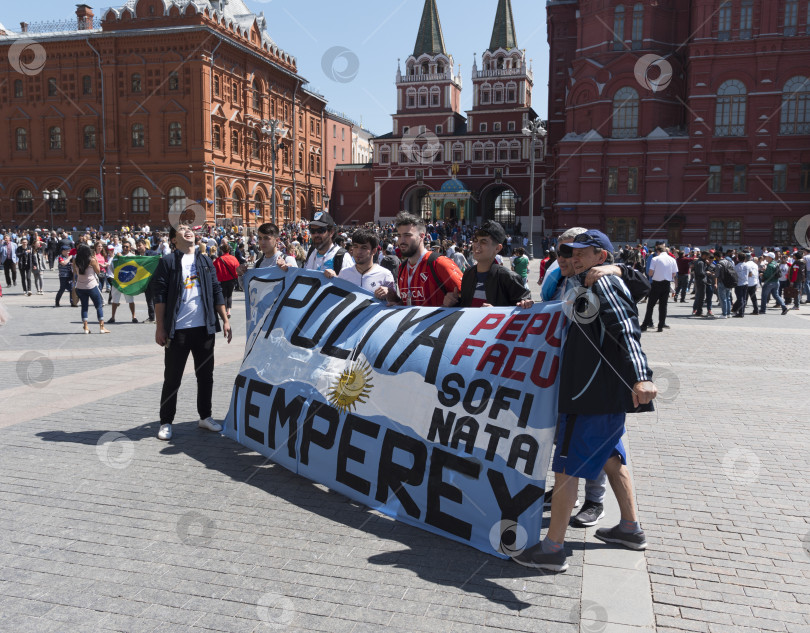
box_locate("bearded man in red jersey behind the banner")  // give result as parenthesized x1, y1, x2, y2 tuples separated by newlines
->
(388, 211, 461, 307)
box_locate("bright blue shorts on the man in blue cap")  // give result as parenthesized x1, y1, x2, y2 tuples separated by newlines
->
(551, 413, 627, 479)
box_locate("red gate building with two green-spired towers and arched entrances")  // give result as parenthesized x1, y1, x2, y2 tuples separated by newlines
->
(331, 0, 545, 239)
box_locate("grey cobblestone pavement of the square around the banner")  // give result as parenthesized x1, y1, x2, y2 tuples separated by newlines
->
(0, 261, 810, 633)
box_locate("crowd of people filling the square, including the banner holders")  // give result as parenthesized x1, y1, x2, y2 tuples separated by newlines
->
(0, 212, 810, 572)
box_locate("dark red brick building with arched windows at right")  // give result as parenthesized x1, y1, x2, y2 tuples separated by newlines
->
(547, 0, 810, 246)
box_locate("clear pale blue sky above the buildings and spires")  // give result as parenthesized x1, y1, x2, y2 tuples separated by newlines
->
(0, 0, 548, 134)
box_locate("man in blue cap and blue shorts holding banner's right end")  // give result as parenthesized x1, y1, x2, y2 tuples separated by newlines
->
(515, 230, 657, 571)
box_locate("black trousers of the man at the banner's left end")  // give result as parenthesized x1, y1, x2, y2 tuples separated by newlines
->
(160, 326, 216, 424)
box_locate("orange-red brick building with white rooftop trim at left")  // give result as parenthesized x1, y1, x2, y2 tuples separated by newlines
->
(0, 0, 326, 226)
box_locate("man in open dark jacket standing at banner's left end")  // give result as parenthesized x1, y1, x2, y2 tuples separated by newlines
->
(150, 225, 231, 440)
